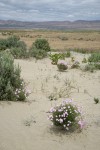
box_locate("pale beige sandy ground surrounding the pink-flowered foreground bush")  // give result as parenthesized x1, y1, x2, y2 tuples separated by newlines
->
(0, 54, 100, 150)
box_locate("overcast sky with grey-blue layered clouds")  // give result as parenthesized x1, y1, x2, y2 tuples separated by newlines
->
(0, 0, 100, 21)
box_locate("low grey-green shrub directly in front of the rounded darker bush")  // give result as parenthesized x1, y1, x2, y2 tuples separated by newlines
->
(29, 47, 47, 59)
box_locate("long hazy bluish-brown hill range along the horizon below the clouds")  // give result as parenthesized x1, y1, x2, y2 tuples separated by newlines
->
(0, 20, 100, 30)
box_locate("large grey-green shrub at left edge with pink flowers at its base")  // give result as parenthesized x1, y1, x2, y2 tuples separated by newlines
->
(0, 51, 29, 101)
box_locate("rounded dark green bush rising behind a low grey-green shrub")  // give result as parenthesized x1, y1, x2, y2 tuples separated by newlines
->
(33, 39, 50, 52)
